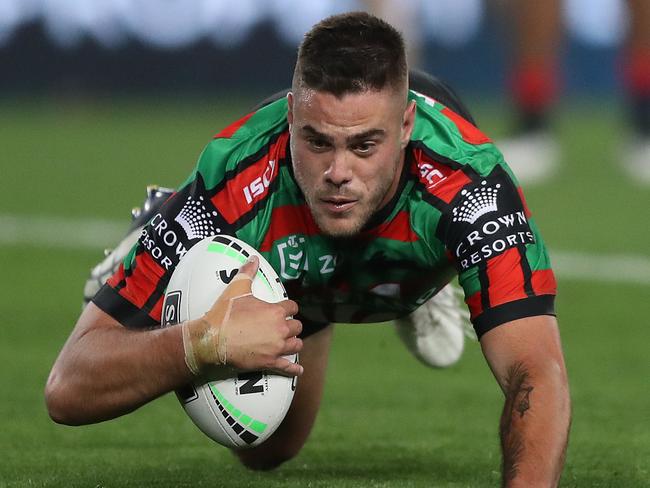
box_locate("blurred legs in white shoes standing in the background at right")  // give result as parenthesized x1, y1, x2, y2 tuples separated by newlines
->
(500, 0, 650, 185)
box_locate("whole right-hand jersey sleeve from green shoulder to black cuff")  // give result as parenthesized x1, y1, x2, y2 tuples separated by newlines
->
(411, 97, 556, 337)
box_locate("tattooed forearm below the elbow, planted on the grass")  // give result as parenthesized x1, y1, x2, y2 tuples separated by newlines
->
(500, 356, 571, 487)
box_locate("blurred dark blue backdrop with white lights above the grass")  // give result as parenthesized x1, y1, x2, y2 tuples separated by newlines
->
(0, 0, 629, 96)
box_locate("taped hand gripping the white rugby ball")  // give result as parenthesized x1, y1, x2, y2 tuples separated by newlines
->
(182, 258, 303, 376)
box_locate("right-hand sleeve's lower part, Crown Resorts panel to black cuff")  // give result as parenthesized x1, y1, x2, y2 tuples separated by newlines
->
(438, 165, 556, 337)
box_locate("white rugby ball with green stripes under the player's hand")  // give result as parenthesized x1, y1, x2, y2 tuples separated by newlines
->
(162, 235, 298, 448)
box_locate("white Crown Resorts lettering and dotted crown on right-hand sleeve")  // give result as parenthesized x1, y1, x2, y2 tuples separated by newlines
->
(451, 180, 535, 270)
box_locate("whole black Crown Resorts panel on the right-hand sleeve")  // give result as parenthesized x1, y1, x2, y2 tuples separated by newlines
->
(439, 166, 535, 272)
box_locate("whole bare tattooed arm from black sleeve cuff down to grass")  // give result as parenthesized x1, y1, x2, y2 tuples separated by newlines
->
(481, 315, 571, 487)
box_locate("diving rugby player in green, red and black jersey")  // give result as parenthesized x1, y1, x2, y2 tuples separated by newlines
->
(46, 13, 570, 486)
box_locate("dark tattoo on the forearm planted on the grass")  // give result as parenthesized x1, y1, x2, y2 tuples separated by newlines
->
(500, 362, 534, 484)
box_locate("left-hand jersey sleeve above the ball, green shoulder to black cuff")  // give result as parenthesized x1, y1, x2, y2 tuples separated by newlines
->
(93, 103, 288, 328)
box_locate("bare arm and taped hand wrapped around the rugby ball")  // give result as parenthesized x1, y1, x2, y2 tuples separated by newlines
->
(45, 261, 302, 425)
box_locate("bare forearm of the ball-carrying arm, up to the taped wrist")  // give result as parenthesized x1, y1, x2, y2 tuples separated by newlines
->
(46, 312, 191, 425)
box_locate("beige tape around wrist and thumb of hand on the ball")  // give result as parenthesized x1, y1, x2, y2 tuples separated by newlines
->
(182, 273, 252, 375)
